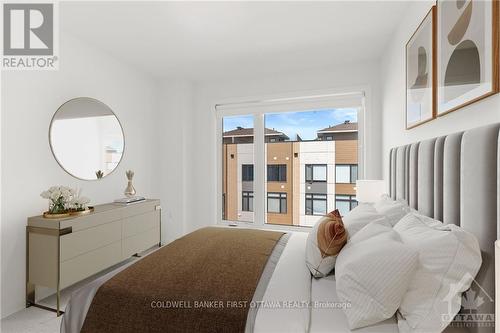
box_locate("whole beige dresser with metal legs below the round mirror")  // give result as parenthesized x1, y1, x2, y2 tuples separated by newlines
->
(26, 200, 161, 315)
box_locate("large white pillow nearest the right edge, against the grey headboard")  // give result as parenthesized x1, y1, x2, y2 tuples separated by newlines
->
(394, 213, 482, 333)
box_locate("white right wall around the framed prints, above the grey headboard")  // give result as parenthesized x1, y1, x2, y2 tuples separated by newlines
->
(381, 1, 500, 179)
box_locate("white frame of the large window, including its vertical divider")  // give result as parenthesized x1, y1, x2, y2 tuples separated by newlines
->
(215, 85, 373, 231)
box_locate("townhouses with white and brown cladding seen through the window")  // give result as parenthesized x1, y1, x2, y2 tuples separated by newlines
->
(222, 121, 358, 226)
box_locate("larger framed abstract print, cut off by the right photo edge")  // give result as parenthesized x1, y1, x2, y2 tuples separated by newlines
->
(437, 0, 500, 116)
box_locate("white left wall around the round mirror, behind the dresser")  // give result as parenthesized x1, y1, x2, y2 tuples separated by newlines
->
(1, 34, 158, 317)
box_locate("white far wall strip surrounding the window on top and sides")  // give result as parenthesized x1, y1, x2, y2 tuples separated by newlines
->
(186, 62, 381, 231)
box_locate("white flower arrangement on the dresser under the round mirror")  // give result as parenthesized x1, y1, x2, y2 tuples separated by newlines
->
(40, 186, 90, 214)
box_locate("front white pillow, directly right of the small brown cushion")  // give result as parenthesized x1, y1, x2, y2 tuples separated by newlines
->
(335, 223, 418, 329)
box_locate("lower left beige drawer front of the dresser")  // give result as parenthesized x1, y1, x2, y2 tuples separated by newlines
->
(60, 241, 122, 288)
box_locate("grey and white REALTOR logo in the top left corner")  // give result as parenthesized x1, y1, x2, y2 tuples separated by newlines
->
(2, 3, 57, 70)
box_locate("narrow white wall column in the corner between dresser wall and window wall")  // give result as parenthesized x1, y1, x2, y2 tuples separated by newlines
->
(155, 80, 194, 242)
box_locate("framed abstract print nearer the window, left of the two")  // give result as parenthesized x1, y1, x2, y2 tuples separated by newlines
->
(405, 6, 437, 130)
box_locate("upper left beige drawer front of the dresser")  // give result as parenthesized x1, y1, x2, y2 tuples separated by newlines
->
(60, 221, 122, 261)
